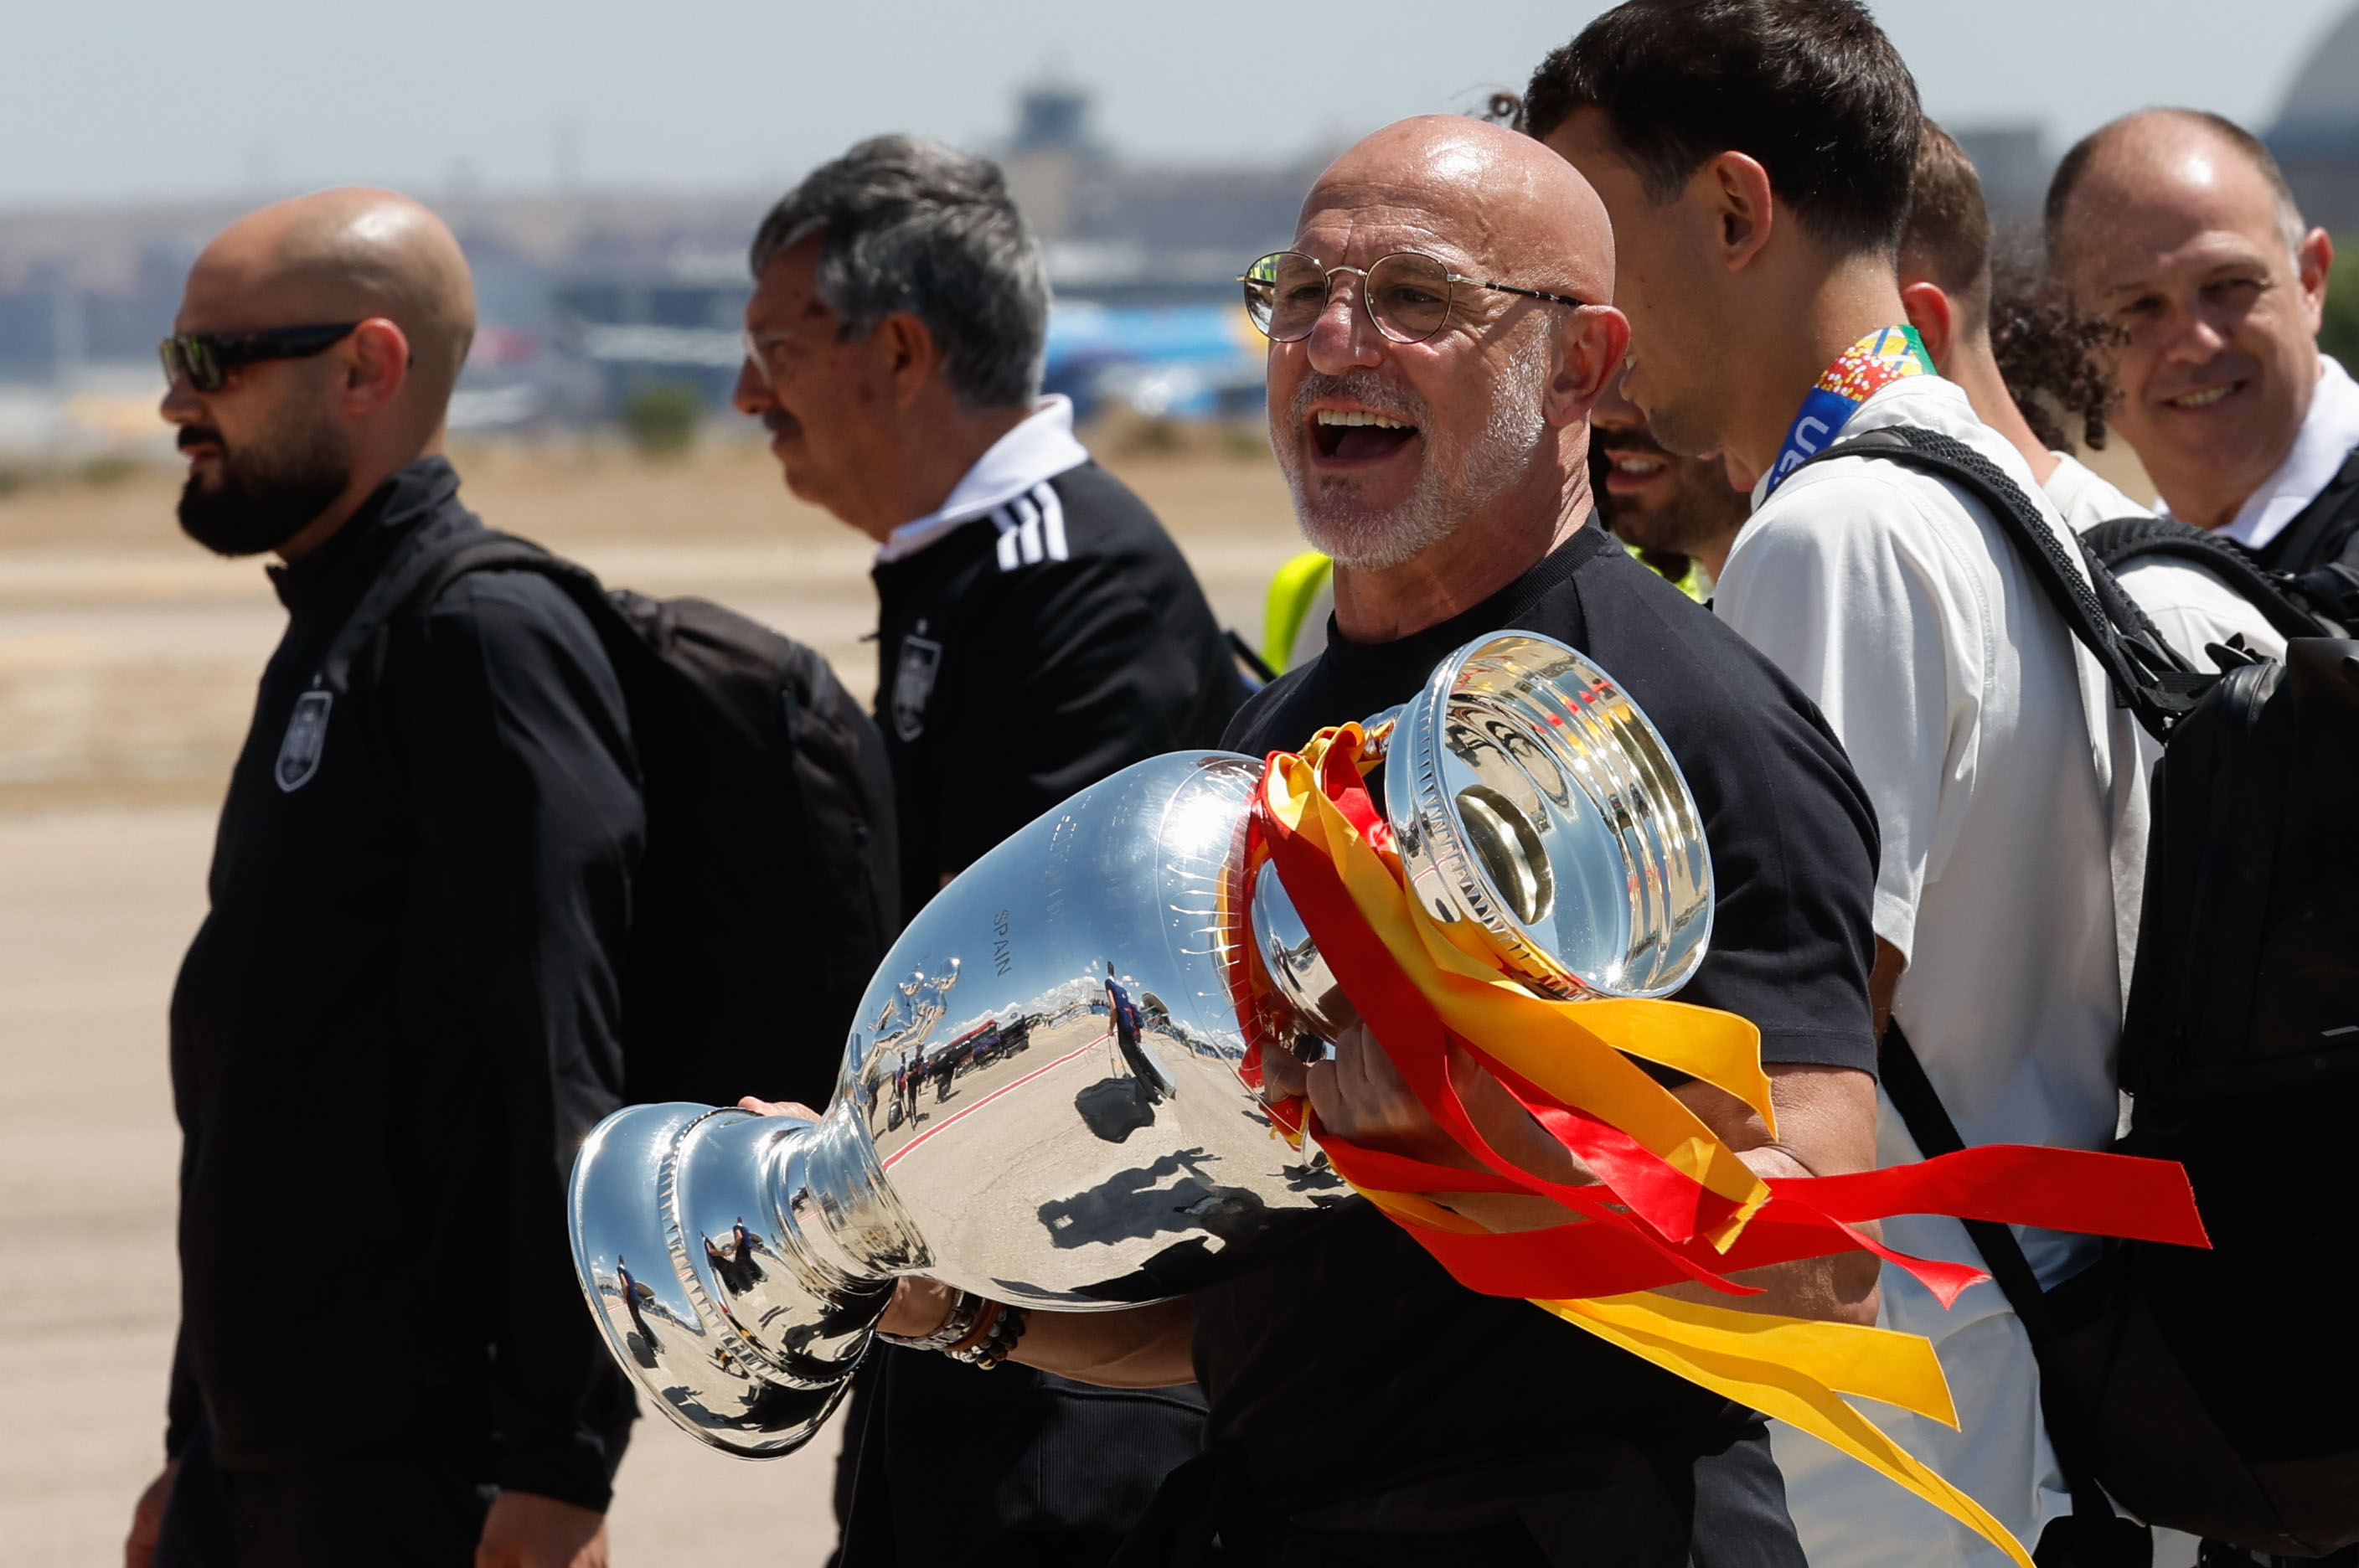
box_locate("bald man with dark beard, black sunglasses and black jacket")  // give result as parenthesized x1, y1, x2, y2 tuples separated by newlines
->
(127, 191, 644, 1568)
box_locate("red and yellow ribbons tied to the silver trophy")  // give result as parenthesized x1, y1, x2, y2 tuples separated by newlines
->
(1255, 724, 2208, 1568)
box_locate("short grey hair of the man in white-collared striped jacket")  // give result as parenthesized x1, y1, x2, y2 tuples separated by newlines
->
(750, 137, 1047, 408)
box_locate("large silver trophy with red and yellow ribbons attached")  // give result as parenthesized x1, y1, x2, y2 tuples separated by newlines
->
(570, 634, 2203, 1563)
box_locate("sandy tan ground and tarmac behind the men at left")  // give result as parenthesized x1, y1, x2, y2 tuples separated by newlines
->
(0, 436, 1298, 1568)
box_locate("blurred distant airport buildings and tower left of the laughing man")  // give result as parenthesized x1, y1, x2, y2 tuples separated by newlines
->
(0, 83, 1324, 441)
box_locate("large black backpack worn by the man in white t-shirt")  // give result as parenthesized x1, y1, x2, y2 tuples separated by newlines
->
(1793, 429, 2359, 1565)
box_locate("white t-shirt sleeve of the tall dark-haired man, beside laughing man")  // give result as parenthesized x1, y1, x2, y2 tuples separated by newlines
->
(1712, 462, 1991, 957)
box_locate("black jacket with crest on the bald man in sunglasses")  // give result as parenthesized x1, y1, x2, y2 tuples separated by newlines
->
(168, 457, 644, 1507)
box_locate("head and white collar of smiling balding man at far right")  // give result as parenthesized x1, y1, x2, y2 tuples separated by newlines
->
(2047, 108, 2359, 594)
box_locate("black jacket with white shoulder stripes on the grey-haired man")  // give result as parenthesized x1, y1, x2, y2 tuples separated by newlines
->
(842, 462, 1246, 1568)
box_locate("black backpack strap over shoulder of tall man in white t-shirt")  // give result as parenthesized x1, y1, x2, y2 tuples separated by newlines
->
(1802, 425, 2217, 740)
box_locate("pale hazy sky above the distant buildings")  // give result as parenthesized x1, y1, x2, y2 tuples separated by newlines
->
(0, 0, 2354, 208)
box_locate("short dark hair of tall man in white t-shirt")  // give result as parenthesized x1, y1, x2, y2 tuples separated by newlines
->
(1524, 0, 1925, 255)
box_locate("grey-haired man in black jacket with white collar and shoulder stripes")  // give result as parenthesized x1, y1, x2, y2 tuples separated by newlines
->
(736, 137, 1246, 1568)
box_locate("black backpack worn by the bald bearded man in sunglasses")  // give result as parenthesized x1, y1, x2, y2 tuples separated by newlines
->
(323, 518, 901, 1106)
